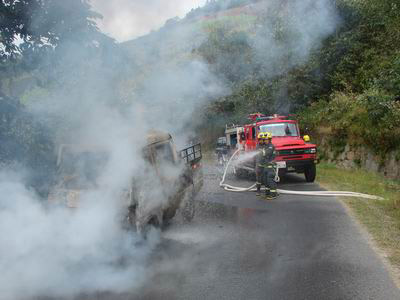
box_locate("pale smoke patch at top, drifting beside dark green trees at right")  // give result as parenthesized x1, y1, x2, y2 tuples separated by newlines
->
(251, 0, 339, 77)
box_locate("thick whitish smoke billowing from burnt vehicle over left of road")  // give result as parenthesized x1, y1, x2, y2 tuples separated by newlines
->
(0, 7, 225, 299)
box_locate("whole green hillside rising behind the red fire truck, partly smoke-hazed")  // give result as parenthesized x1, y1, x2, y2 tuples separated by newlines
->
(124, 0, 400, 163)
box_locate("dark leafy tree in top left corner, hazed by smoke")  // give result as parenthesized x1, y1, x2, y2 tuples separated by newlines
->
(0, 0, 115, 97)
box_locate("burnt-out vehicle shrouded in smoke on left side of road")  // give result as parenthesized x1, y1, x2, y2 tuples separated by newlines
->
(48, 131, 203, 233)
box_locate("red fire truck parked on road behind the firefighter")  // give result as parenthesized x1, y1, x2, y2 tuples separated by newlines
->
(235, 113, 318, 182)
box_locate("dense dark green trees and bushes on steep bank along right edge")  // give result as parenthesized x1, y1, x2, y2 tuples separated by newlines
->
(301, 1, 400, 157)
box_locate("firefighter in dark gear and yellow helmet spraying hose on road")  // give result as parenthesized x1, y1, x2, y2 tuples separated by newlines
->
(256, 132, 278, 199)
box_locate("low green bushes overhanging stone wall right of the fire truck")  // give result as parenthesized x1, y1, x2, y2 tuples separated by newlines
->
(300, 89, 400, 157)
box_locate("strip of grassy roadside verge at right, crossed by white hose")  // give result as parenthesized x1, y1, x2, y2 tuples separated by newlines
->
(317, 163, 400, 268)
